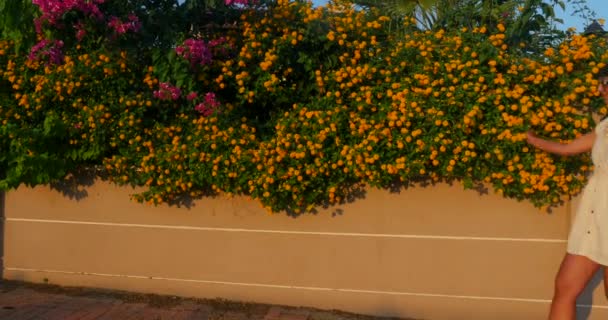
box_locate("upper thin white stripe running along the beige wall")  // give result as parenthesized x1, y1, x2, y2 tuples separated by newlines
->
(5, 218, 566, 243)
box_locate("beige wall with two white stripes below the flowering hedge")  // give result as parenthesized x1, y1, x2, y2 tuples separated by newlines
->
(4, 182, 608, 320)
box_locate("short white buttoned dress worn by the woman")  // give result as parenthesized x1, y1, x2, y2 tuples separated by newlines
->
(567, 118, 608, 266)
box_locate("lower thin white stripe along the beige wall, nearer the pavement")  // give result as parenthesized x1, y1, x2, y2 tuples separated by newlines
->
(4, 267, 608, 309)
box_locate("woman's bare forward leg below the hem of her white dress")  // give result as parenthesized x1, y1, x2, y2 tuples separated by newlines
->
(549, 253, 600, 320)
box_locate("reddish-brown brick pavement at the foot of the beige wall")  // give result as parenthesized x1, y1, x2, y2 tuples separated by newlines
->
(0, 281, 400, 320)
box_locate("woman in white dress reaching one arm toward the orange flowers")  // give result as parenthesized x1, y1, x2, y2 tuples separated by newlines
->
(527, 68, 608, 320)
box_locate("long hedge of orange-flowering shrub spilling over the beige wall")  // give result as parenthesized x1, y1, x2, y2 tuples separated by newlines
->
(0, 0, 608, 212)
